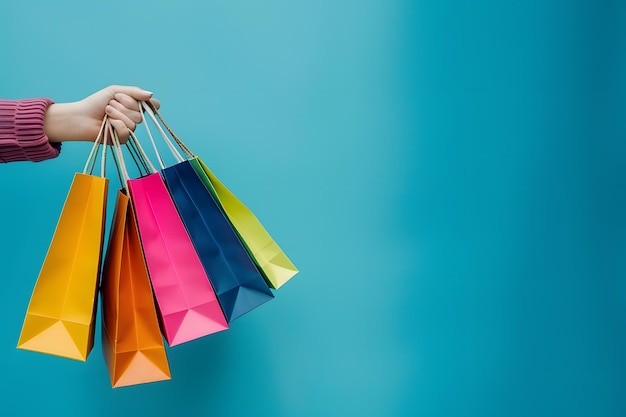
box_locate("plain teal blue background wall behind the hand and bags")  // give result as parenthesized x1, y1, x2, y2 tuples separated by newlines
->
(0, 0, 626, 417)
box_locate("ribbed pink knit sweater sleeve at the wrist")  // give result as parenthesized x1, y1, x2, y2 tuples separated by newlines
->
(0, 98, 61, 162)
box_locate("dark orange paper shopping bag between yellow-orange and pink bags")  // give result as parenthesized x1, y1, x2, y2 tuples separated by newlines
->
(101, 189, 171, 388)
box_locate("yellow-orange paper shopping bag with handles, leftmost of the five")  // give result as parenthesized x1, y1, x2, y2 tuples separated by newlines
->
(17, 121, 108, 361)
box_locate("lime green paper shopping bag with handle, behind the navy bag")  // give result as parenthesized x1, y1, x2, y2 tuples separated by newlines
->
(144, 103, 298, 289)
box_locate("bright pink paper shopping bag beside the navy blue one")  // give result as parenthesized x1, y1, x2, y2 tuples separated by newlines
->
(128, 160, 228, 346)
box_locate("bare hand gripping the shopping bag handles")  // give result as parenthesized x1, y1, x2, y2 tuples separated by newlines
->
(44, 85, 160, 143)
